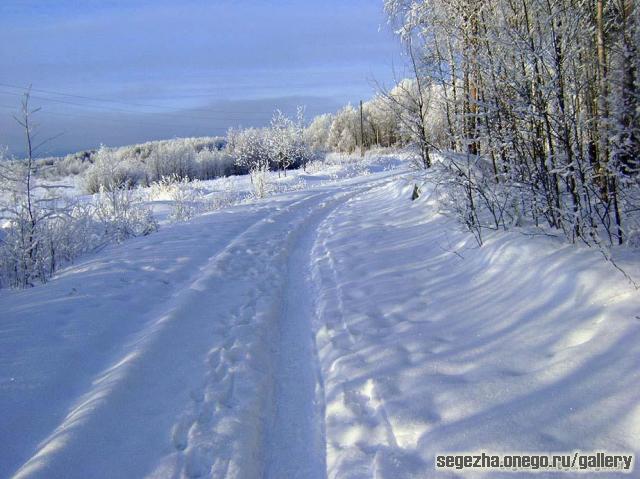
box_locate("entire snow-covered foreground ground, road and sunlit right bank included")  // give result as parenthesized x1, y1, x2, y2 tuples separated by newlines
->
(0, 156, 640, 479)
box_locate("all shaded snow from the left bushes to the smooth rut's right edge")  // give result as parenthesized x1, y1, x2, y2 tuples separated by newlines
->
(0, 171, 400, 478)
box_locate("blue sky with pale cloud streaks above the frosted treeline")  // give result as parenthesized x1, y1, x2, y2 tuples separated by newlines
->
(0, 0, 402, 155)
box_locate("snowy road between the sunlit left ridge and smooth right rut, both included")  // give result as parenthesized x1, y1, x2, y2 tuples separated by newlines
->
(10, 174, 396, 479)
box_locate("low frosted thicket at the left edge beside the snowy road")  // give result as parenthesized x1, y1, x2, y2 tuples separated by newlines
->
(0, 179, 157, 288)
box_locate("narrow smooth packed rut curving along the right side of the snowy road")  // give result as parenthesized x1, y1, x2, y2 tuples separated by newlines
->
(265, 175, 404, 479)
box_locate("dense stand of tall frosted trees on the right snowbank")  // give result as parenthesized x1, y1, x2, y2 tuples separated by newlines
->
(385, 0, 640, 249)
